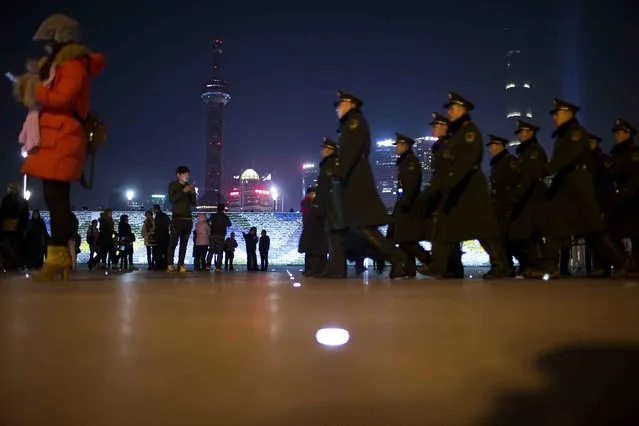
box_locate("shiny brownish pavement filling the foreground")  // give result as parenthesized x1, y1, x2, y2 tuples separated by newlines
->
(0, 270, 639, 426)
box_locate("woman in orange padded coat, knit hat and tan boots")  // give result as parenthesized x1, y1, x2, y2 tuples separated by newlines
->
(15, 14, 104, 280)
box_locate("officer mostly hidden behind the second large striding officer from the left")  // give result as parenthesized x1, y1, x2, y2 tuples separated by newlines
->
(424, 112, 464, 279)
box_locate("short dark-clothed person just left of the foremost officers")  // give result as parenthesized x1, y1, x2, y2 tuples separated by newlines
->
(297, 186, 328, 277)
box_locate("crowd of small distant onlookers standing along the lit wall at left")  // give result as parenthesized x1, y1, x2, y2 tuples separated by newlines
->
(0, 184, 270, 272)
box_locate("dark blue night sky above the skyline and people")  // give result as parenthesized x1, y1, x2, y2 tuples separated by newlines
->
(0, 0, 639, 208)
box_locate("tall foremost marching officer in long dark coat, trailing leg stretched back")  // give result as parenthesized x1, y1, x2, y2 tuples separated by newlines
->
(333, 91, 407, 278)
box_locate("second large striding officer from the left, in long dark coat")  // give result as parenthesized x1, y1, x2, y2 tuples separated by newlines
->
(419, 93, 511, 279)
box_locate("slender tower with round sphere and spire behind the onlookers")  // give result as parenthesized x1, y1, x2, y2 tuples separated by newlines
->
(198, 39, 231, 206)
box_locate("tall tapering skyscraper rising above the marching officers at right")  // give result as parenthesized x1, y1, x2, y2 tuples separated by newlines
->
(505, 27, 533, 125)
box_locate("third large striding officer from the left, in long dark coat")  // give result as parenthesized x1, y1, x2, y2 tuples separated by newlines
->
(529, 99, 626, 278)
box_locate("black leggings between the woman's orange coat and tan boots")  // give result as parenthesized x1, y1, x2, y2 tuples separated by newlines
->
(42, 180, 73, 247)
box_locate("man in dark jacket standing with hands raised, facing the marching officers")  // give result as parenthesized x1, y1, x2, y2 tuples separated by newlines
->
(168, 166, 197, 272)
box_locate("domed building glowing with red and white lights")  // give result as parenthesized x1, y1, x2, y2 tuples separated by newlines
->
(226, 169, 273, 212)
